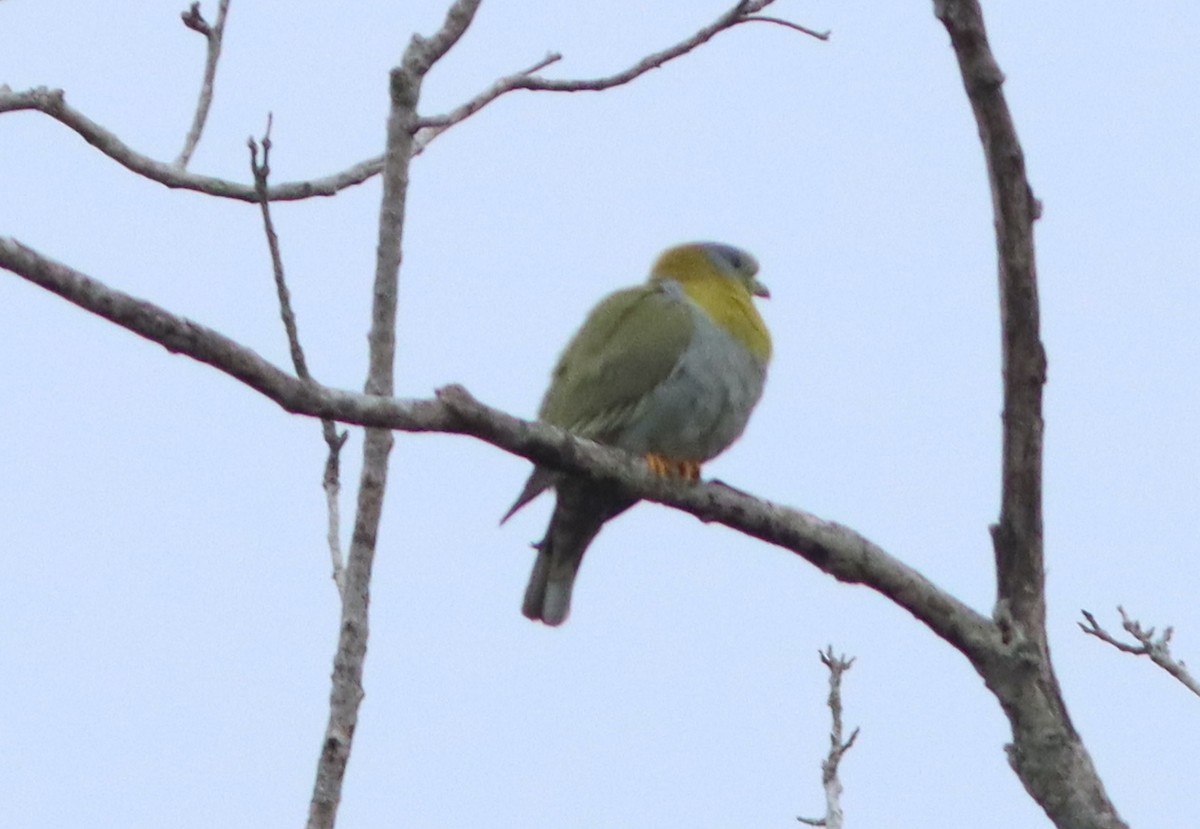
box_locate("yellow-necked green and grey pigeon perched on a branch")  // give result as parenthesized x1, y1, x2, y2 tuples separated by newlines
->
(500, 241, 772, 626)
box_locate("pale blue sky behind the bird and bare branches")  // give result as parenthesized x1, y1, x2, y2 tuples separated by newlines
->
(0, 0, 1200, 829)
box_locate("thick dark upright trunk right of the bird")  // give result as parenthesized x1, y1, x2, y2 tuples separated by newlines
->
(934, 0, 1124, 829)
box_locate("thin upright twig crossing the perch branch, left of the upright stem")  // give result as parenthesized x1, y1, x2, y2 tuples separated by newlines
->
(246, 114, 349, 594)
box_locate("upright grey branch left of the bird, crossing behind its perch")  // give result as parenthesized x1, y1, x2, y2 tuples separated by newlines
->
(308, 6, 480, 829)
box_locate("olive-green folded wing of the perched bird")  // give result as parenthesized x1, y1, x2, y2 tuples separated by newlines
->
(539, 286, 694, 441)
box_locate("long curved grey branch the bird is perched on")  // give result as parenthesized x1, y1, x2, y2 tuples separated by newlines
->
(0, 238, 1003, 663)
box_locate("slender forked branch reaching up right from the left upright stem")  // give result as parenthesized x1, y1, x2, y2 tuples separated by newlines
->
(416, 0, 829, 149)
